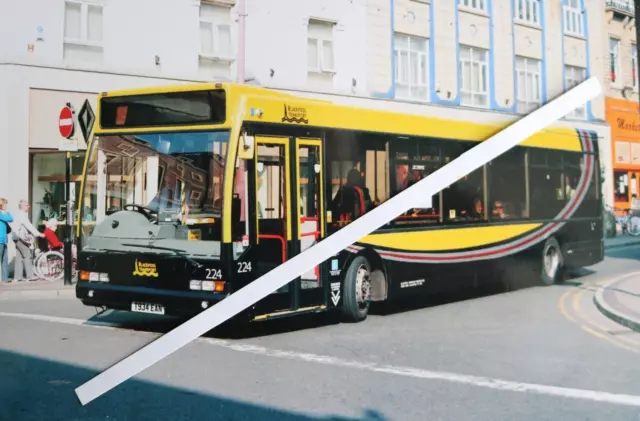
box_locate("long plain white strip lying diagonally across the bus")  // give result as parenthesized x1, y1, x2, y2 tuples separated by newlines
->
(75, 77, 602, 405)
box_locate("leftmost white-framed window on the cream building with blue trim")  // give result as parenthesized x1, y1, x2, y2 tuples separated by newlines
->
(393, 32, 430, 102)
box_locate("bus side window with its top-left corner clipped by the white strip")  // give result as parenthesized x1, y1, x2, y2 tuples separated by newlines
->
(487, 148, 528, 220)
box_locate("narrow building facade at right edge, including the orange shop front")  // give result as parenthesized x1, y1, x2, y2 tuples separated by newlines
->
(604, 0, 640, 214)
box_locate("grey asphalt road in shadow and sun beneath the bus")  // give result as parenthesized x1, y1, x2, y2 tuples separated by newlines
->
(0, 247, 640, 421)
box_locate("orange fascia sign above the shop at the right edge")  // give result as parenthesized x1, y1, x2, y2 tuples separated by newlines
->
(605, 98, 640, 168)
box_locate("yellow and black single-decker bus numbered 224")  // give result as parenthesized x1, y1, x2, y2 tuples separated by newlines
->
(76, 83, 604, 322)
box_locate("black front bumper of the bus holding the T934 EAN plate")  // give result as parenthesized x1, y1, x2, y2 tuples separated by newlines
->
(76, 281, 228, 317)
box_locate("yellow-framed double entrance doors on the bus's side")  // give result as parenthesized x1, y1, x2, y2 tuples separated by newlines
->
(254, 136, 324, 318)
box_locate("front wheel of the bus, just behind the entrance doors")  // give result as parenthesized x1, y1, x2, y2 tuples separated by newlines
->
(341, 256, 371, 323)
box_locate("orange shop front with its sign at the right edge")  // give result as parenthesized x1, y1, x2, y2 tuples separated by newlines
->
(606, 98, 640, 216)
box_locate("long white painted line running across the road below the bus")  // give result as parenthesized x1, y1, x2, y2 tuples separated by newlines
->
(0, 312, 640, 407)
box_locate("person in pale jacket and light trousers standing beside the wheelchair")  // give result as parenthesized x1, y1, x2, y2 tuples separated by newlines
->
(13, 200, 44, 282)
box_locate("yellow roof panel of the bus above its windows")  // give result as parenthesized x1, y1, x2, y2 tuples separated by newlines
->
(97, 82, 596, 151)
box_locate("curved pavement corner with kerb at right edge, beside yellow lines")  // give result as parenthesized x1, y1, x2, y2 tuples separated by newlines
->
(593, 274, 640, 332)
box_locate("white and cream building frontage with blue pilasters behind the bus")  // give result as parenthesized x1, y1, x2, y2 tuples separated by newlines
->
(0, 0, 613, 262)
